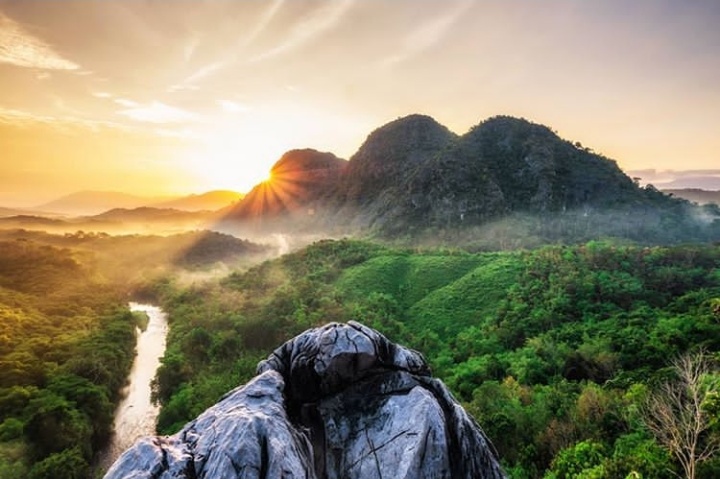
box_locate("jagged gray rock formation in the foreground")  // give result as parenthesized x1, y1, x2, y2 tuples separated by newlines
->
(105, 322, 504, 479)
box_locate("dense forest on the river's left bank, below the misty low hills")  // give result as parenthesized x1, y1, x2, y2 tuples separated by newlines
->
(0, 240, 135, 479)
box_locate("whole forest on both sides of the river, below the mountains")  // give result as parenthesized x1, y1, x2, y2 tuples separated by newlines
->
(0, 231, 720, 479)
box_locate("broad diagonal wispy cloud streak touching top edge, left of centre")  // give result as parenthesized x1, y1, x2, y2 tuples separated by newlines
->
(250, 0, 355, 63)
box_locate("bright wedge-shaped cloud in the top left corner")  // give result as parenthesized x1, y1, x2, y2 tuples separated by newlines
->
(0, 13, 80, 70)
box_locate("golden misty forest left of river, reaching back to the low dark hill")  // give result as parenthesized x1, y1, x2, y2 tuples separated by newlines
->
(0, 230, 268, 479)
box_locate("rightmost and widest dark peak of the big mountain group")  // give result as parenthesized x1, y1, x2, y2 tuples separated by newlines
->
(368, 116, 660, 232)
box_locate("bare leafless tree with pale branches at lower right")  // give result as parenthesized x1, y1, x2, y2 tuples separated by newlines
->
(642, 351, 720, 479)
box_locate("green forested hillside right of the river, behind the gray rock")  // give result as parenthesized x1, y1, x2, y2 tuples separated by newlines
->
(147, 240, 720, 479)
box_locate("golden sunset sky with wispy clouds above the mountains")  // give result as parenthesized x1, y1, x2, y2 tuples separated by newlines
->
(0, 0, 720, 206)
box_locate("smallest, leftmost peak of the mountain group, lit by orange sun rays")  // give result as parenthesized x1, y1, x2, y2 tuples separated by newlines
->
(224, 149, 347, 221)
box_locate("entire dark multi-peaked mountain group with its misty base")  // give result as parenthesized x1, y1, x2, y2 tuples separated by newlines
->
(218, 115, 720, 247)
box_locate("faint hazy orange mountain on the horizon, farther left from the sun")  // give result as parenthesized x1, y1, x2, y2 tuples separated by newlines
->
(33, 191, 177, 216)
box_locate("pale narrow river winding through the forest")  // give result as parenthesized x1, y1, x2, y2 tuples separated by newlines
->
(99, 303, 168, 470)
